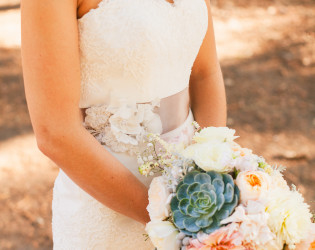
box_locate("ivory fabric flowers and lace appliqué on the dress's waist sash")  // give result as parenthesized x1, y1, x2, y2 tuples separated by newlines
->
(83, 99, 162, 155)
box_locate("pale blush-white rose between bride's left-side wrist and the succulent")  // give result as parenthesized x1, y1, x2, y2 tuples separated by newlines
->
(147, 176, 170, 221)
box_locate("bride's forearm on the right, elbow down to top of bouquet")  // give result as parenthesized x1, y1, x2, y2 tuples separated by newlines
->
(189, 67, 227, 127)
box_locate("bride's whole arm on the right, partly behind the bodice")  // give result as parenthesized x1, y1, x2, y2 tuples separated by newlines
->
(189, 0, 227, 127)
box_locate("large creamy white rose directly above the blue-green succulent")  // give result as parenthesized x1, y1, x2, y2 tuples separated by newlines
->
(183, 142, 232, 172)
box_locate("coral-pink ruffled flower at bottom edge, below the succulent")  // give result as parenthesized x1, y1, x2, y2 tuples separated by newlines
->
(187, 223, 254, 250)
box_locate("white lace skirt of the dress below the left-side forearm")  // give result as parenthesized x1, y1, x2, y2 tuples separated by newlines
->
(52, 170, 154, 250)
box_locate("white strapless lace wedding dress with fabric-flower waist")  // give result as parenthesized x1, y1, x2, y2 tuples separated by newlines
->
(52, 0, 208, 250)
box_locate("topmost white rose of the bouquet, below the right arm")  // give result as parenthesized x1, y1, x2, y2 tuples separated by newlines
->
(193, 127, 239, 143)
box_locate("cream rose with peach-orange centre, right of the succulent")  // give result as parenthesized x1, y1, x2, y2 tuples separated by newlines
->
(236, 171, 271, 204)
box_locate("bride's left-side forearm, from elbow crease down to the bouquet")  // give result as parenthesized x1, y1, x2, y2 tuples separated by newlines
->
(39, 126, 149, 223)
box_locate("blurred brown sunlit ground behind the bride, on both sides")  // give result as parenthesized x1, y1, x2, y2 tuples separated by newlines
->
(0, 0, 315, 250)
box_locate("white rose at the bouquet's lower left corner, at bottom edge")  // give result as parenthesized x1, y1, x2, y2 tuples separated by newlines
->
(145, 221, 179, 250)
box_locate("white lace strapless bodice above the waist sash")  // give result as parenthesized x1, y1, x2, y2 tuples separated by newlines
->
(78, 0, 208, 108)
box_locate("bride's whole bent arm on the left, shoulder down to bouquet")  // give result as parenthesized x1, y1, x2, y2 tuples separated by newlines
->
(21, 0, 149, 223)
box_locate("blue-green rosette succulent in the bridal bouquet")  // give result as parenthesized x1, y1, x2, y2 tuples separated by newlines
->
(171, 171, 239, 236)
